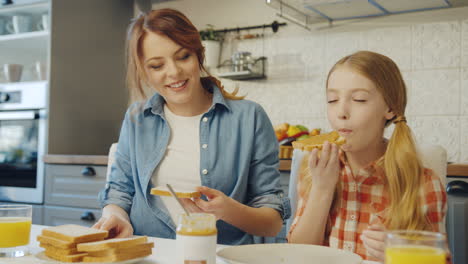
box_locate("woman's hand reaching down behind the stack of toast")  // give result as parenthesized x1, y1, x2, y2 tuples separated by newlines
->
(92, 204, 133, 238)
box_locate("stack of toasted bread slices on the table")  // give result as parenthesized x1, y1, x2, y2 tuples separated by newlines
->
(37, 225, 154, 262)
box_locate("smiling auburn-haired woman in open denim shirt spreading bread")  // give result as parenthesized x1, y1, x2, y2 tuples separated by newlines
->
(95, 9, 290, 244)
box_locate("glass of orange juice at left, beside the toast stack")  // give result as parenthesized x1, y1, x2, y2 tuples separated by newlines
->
(0, 204, 32, 257)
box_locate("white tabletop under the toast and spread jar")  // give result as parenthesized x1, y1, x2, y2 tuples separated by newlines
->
(0, 225, 378, 264)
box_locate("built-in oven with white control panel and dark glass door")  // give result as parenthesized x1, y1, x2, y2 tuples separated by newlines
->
(0, 82, 47, 204)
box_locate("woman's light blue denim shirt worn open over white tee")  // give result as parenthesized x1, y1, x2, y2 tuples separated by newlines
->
(99, 83, 291, 245)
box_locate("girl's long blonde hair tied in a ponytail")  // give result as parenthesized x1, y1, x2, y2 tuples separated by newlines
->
(299, 51, 430, 230)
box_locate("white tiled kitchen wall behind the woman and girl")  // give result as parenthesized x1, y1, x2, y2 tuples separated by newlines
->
(153, 0, 468, 163)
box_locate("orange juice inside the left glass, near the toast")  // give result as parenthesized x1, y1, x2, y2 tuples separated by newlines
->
(0, 217, 31, 248)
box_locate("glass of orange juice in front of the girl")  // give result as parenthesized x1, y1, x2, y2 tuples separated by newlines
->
(385, 231, 447, 264)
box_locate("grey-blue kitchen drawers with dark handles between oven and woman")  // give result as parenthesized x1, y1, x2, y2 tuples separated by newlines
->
(43, 158, 107, 226)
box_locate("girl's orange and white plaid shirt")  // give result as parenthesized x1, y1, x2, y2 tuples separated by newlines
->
(288, 153, 447, 260)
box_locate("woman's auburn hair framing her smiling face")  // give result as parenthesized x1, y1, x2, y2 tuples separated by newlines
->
(126, 8, 244, 102)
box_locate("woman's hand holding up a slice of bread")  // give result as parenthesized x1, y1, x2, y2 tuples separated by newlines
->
(177, 186, 235, 220)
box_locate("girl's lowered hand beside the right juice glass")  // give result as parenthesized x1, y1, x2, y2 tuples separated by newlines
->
(361, 224, 385, 262)
